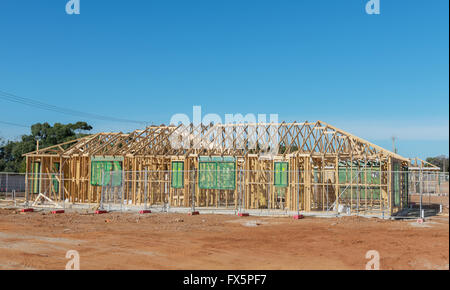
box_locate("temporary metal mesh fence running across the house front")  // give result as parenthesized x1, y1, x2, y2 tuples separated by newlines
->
(14, 168, 449, 215)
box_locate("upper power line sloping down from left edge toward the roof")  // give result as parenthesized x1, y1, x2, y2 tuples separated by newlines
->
(0, 90, 147, 124)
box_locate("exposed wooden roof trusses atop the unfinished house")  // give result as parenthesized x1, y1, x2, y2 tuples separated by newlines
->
(27, 121, 408, 161)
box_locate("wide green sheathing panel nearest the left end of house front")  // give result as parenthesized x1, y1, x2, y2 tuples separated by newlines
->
(91, 160, 122, 186)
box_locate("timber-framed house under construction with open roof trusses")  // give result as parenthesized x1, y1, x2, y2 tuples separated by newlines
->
(25, 121, 428, 215)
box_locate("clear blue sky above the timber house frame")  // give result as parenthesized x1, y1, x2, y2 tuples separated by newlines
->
(0, 0, 449, 158)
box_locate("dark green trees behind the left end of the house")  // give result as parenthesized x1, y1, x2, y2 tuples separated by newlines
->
(0, 122, 92, 172)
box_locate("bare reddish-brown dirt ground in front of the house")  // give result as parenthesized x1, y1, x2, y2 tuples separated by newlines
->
(0, 209, 449, 269)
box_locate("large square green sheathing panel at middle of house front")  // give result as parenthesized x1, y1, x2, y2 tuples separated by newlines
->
(198, 156, 236, 190)
